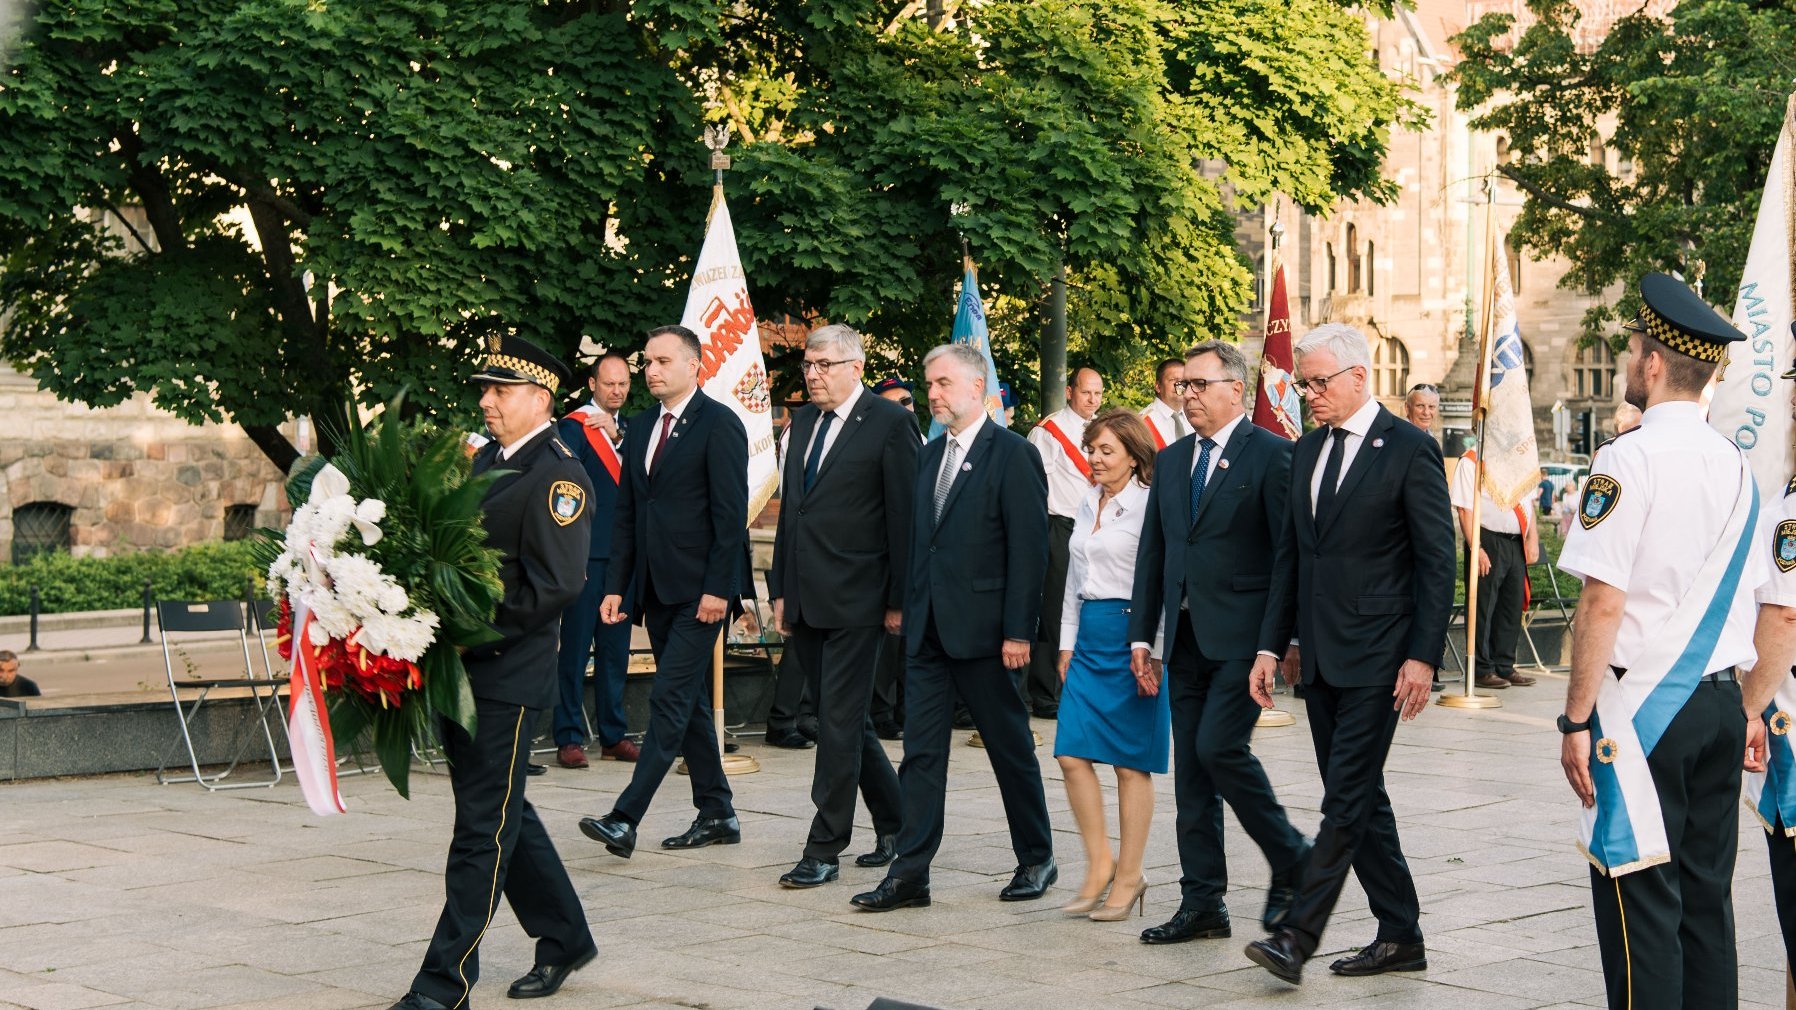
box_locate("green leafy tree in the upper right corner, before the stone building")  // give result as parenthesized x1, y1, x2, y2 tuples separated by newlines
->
(1453, 0, 1796, 338)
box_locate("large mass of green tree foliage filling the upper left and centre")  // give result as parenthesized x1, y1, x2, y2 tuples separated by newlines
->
(0, 0, 1412, 456)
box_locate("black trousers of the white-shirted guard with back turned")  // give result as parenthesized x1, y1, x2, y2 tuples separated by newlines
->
(1589, 679, 1746, 1010)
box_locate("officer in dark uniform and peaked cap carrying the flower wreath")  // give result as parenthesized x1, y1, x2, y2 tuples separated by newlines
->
(392, 334, 598, 1010)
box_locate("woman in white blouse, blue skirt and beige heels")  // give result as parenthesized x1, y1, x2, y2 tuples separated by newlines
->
(1054, 410, 1173, 922)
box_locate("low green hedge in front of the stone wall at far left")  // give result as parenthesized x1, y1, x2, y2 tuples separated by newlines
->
(0, 541, 260, 616)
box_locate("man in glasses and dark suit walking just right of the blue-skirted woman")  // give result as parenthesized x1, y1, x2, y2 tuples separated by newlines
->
(1130, 340, 1307, 944)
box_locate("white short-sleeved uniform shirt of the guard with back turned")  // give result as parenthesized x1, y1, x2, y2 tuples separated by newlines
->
(1559, 401, 1760, 672)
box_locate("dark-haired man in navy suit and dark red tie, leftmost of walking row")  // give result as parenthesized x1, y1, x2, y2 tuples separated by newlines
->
(580, 325, 749, 859)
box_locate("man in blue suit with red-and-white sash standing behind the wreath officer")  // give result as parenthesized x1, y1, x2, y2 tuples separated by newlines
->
(555, 352, 638, 767)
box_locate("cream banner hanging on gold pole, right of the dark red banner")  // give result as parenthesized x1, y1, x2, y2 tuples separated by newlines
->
(1471, 226, 1541, 509)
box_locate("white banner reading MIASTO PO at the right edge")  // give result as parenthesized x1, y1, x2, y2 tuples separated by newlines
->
(1708, 97, 1796, 501)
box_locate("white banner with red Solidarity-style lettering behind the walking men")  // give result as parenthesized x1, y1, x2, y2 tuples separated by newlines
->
(681, 189, 779, 523)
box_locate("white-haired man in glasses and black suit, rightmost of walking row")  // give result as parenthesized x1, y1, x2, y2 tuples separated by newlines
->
(1246, 323, 1453, 985)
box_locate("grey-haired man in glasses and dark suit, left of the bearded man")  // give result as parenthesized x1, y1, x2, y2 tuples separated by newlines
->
(767, 325, 918, 888)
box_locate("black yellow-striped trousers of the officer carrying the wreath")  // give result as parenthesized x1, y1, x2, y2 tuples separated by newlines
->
(411, 697, 596, 1008)
